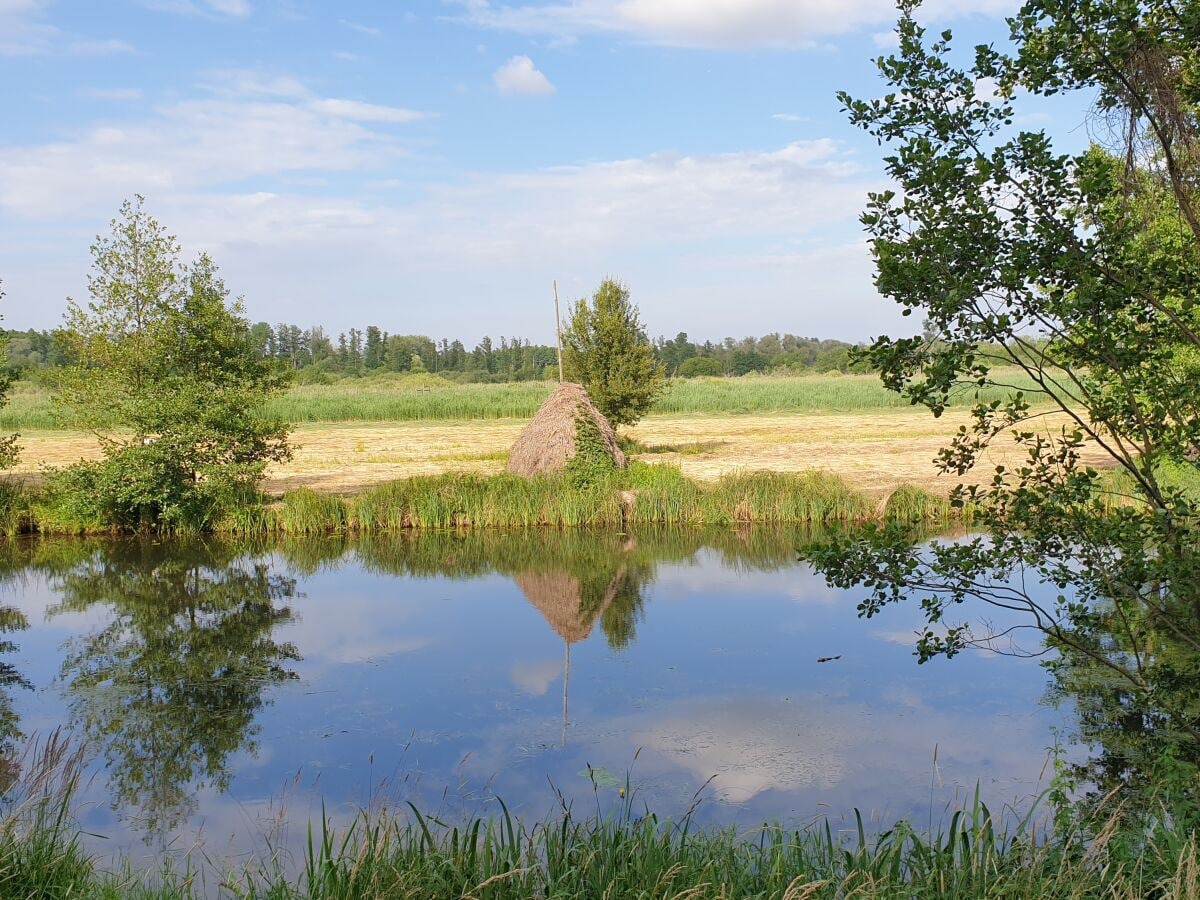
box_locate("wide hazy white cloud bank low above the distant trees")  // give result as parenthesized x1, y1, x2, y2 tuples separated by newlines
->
(0, 78, 890, 338)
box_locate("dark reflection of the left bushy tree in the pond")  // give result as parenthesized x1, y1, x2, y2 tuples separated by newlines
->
(49, 541, 300, 833)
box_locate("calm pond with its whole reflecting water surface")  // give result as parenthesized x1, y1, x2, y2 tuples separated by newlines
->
(0, 529, 1066, 868)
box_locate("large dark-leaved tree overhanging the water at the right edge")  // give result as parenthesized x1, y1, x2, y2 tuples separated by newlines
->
(811, 0, 1200, 798)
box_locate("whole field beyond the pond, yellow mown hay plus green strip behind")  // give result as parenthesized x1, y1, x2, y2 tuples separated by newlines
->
(0, 374, 1103, 504)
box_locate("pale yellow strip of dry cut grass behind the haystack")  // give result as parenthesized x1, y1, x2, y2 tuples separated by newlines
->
(7, 409, 1104, 496)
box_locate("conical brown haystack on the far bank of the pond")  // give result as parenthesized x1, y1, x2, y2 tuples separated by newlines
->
(509, 382, 625, 476)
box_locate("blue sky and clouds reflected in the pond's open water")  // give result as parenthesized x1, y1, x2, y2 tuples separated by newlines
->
(0, 540, 1057, 864)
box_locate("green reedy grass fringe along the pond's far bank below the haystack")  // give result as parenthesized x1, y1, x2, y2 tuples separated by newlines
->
(0, 462, 960, 534)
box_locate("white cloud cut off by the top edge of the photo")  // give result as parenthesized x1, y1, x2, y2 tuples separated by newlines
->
(451, 0, 1016, 47)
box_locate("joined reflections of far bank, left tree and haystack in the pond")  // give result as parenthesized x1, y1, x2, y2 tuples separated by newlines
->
(0, 528, 974, 834)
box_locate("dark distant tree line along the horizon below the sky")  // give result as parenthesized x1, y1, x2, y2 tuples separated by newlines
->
(0, 322, 873, 383)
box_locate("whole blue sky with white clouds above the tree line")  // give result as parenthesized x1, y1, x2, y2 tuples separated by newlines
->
(0, 0, 1086, 346)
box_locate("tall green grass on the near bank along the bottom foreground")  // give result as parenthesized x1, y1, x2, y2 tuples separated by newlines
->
(0, 777, 1200, 900)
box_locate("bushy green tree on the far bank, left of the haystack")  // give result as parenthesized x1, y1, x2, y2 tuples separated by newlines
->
(52, 197, 289, 528)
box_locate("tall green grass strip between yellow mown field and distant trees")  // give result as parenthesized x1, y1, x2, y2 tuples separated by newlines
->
(0, 373, 1051, 431)
